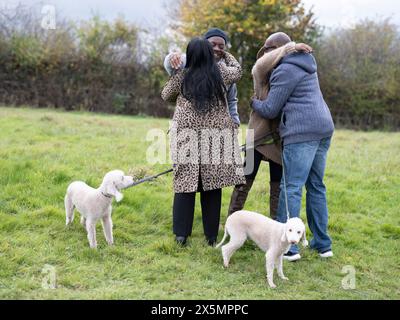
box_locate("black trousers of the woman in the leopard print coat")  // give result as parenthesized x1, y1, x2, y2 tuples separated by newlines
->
(173, 176, 222, 240)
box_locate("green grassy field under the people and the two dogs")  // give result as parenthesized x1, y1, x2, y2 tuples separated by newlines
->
(0, 107, 400, 300)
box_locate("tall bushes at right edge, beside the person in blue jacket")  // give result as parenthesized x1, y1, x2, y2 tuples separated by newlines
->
(316, 20, 400, 130)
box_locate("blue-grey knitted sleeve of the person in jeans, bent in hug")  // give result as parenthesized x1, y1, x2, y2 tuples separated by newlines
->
(252, 64, 301, 119)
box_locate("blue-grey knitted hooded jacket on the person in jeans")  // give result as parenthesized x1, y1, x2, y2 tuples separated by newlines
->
(252, 53, 334, 145)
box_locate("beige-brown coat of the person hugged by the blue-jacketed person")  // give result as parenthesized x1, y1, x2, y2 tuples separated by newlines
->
(246, 42, 295, 164)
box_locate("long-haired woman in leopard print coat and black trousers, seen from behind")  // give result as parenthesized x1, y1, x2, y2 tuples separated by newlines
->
(161, 39, 245, 244)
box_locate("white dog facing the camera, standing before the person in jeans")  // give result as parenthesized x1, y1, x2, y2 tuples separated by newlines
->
(216, 211, 308, 288)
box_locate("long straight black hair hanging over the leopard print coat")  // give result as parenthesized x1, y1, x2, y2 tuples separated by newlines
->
(182, 38, 226, 112)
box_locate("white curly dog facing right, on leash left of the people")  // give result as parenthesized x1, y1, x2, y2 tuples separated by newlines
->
(65, 170, 133, 248)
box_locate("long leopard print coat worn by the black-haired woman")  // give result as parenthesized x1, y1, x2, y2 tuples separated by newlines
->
(161, 53, 246, 193)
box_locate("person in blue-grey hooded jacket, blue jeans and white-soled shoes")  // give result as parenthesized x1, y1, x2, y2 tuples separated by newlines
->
(252, 53, 334, 261)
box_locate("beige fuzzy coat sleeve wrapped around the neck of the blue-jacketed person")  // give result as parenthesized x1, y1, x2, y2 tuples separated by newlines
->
(251, 42, 296, 99)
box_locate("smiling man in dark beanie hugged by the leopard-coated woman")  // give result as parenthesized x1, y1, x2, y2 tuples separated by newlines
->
(164, 28, 240, 127)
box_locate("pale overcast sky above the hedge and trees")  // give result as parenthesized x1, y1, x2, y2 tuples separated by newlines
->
(0, 0, 400, 27)
